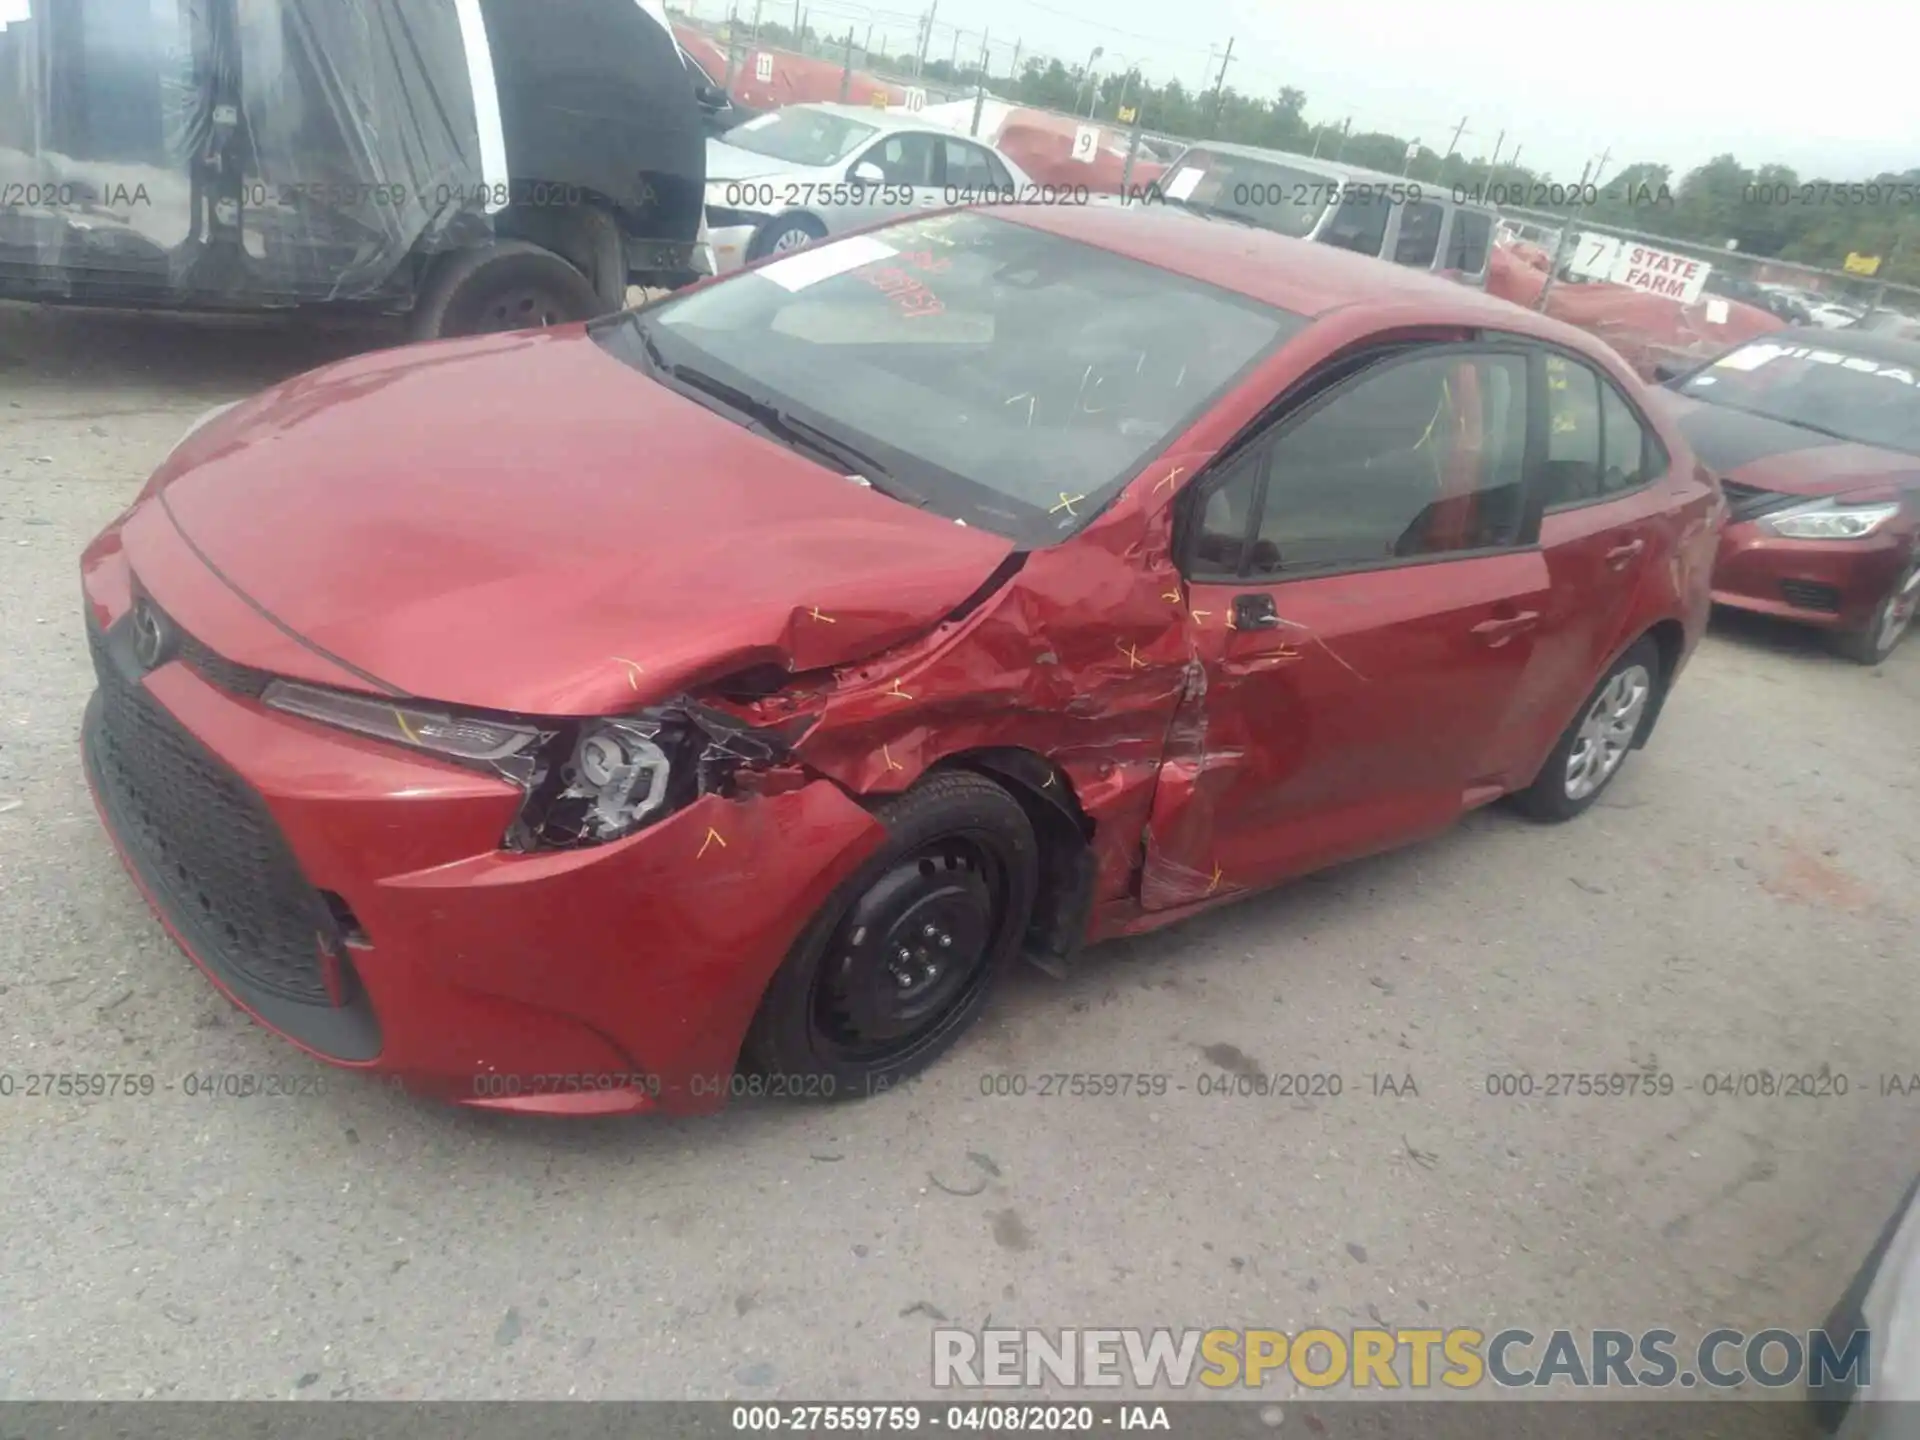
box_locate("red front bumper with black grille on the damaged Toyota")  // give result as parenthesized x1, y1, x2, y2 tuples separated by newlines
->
(83, 529, 881, 1114)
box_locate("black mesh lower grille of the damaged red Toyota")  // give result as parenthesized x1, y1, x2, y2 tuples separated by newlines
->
(86, 626, 336, 1006)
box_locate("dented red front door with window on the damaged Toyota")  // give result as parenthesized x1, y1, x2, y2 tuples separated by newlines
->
(1140, 346, 1549, 910)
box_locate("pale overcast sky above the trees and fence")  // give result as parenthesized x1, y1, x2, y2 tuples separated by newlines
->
(771, 0, 1920, 180)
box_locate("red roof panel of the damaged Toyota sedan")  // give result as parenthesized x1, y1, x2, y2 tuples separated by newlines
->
(985, 205, 1599, 339)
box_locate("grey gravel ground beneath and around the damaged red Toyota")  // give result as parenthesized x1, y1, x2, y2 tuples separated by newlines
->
(0, 311, 1920, 1400)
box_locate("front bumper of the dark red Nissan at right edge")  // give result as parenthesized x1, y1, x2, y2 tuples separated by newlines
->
(1713, 520, 1912, 630)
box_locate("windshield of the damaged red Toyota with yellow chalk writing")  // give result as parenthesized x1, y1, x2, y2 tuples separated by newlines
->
(599, 213, 1308, 545)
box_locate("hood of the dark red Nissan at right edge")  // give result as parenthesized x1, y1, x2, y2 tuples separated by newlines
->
(1655, 390, 1920, 497)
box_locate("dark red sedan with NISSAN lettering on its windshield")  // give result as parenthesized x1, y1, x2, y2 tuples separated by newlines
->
(1663, 330, 1920, 664)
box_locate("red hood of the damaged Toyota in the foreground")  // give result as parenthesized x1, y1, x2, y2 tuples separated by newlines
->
(127, 326, 1014, 714)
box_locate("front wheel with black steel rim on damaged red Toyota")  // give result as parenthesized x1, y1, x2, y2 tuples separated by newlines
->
(741, 770, 1039, 1100)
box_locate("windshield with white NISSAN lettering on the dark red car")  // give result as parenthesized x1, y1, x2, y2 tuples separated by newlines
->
(1680, 340, 1920, 455)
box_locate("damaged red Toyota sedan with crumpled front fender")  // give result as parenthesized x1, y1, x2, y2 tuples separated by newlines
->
(84, 207, 1724, 1114)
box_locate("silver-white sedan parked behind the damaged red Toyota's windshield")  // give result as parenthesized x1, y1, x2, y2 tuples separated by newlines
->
(707, 104, 1031, 275)
